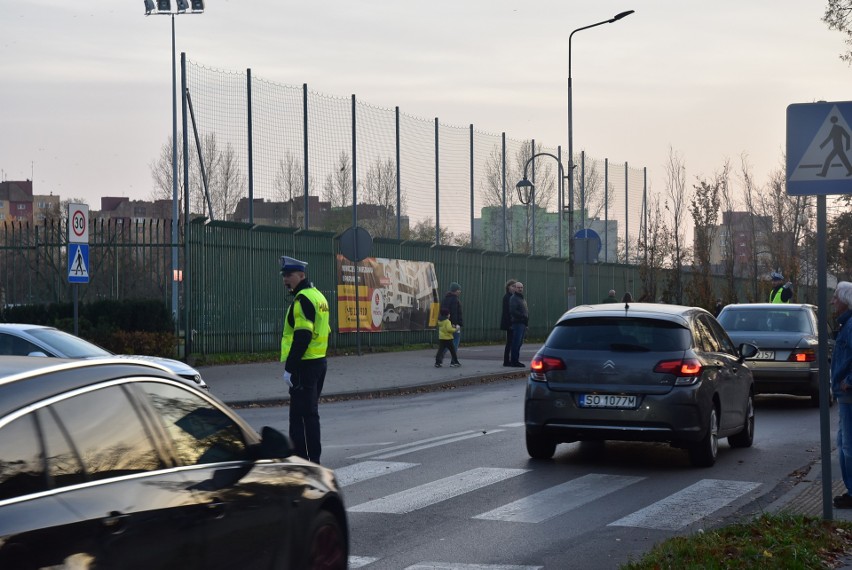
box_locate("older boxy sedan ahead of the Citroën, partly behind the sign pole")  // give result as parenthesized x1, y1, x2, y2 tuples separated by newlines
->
(719, 303, 834, 406)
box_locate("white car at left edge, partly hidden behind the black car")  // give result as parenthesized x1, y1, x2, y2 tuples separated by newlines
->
(0, 323, 209, 390)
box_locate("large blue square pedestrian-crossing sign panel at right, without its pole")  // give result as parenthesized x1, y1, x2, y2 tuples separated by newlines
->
(787, 102, 852, 196)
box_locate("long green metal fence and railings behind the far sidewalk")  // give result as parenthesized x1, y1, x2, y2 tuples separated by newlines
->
(5, 219, 816, 354)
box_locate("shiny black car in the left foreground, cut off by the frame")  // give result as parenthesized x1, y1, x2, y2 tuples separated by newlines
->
(0, 356, 349, 570)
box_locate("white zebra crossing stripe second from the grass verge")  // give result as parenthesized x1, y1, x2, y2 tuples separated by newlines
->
(473, 473, 645, 523)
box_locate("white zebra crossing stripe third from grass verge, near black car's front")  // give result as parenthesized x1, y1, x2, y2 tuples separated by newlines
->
(348, 467, 529, 515)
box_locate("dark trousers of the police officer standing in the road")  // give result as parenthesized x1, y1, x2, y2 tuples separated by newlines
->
(290, 358, 328, 463)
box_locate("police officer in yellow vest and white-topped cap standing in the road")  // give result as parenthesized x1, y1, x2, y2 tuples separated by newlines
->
(281, 255, 331, 463)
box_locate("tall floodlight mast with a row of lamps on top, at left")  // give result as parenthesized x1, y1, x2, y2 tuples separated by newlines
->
(144, 0, 204, 348)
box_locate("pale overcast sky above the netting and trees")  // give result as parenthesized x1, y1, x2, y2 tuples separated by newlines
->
(0, 0, 852, 209)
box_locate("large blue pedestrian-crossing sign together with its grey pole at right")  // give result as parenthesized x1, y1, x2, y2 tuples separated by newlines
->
(787, 101, 852, 520)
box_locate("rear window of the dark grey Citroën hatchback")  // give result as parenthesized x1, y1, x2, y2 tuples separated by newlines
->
(546, 317, 692, 351)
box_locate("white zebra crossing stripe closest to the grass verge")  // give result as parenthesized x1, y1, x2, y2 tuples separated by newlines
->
(609, 479, 760, 530)
